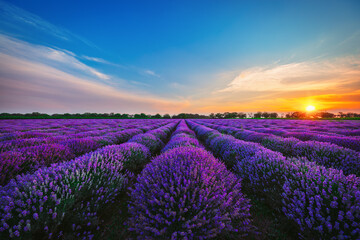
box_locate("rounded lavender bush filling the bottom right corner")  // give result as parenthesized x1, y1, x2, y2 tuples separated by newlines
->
(282, 158, 360, 239)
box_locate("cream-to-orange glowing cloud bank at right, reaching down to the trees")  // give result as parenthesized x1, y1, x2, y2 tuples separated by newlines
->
(178, 55, 360, 113)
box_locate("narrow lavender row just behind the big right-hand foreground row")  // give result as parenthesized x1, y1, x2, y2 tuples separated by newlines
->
(195, 122, 360, 175)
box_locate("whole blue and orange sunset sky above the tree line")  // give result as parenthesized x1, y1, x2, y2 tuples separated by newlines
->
(0, 0, 360, 114)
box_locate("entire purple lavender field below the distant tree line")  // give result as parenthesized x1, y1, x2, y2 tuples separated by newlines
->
(0, 119, 360, 239)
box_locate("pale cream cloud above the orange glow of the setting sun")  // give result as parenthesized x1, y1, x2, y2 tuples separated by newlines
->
(217, 57, 360, 93)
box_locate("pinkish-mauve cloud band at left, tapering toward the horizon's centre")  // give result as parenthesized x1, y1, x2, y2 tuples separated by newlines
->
(0, 50, 189, 113)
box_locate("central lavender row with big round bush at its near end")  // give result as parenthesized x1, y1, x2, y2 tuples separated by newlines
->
(127, 121, 251, 239)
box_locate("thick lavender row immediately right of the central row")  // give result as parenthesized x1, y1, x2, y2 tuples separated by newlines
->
(188, 121, 360, 239)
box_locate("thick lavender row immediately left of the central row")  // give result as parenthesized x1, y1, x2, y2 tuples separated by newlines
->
(0, 122, 176, 239)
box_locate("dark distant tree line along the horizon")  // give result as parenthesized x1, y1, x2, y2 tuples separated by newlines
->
(0, 111, 360, 119)
